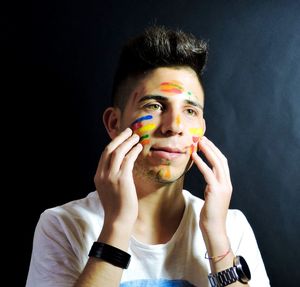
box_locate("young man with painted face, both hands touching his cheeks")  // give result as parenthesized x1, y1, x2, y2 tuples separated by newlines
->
(27, 27, 269, 287)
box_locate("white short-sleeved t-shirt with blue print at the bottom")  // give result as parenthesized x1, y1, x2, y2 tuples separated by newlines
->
(26, 190, 270, 287)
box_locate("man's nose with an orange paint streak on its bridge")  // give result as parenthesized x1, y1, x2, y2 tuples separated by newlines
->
(161, 110, 183, 136)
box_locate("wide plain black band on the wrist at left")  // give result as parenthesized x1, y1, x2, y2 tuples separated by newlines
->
(89, 242, 131, 269)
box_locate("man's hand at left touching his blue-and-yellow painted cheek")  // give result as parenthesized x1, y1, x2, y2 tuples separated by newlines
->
(94, 128, 143, 232)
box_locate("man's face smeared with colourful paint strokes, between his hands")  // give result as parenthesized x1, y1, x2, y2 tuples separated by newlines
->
(121, 68, 205, 182)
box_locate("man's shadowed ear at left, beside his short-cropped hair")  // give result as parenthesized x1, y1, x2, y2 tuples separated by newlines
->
(102, 107, 121, 139)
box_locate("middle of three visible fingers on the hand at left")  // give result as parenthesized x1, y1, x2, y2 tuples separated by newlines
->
(109, 134, 140, 175)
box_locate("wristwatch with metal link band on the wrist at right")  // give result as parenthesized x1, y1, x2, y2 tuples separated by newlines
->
(208, 256, 251, 287)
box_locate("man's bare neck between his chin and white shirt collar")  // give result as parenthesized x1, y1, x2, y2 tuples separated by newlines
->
(133, 177, 185, 244)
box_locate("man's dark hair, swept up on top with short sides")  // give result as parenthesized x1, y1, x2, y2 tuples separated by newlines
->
(112, 26, 208, 110)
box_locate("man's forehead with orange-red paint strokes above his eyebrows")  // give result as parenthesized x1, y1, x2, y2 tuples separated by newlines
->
(129, 68, 204, 103)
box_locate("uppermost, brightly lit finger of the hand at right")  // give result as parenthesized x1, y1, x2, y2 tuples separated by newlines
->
(198, 138, 226, 180)
